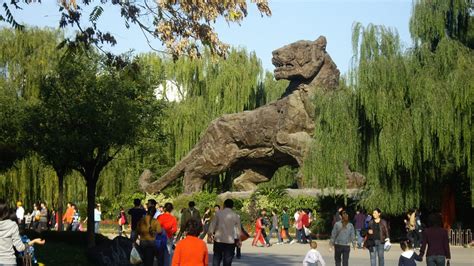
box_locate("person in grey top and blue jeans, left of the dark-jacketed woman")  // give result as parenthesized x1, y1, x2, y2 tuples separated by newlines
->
(330, 210, 356, 266)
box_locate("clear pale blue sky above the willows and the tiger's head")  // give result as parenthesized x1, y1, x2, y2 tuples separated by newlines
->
(6, 0, 412, 73)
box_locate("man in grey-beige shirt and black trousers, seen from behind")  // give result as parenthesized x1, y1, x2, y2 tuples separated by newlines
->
(209, 199, 241, 266)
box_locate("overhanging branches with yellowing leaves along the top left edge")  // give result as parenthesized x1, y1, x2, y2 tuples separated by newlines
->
(0, 0, 271, 59)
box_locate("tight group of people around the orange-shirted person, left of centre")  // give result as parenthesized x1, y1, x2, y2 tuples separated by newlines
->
(125, 199, 241, 266)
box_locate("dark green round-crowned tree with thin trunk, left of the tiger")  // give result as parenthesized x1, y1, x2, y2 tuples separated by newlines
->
(28, 49, 162, 247)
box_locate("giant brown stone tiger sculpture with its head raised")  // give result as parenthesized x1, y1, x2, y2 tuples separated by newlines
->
(139, 36, 362, 193)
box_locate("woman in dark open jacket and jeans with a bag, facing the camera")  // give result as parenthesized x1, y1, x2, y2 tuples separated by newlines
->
(366, 208, 390, 266)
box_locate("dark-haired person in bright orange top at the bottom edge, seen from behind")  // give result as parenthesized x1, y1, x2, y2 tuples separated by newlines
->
(172, 219, 209, 266)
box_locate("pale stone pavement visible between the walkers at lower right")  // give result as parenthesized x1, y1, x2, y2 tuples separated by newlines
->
(207, 238, 474, 266)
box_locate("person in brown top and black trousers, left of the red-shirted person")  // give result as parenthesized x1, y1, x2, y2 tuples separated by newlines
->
(137, 207, 163, 266)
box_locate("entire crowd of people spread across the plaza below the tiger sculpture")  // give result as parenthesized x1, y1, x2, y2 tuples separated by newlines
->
(0, 196, 451, 266)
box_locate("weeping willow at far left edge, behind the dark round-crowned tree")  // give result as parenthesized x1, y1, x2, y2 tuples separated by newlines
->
(0, 28, 62, 171)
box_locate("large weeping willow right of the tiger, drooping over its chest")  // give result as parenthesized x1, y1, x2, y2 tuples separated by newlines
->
(306, 0, 474, 214)
